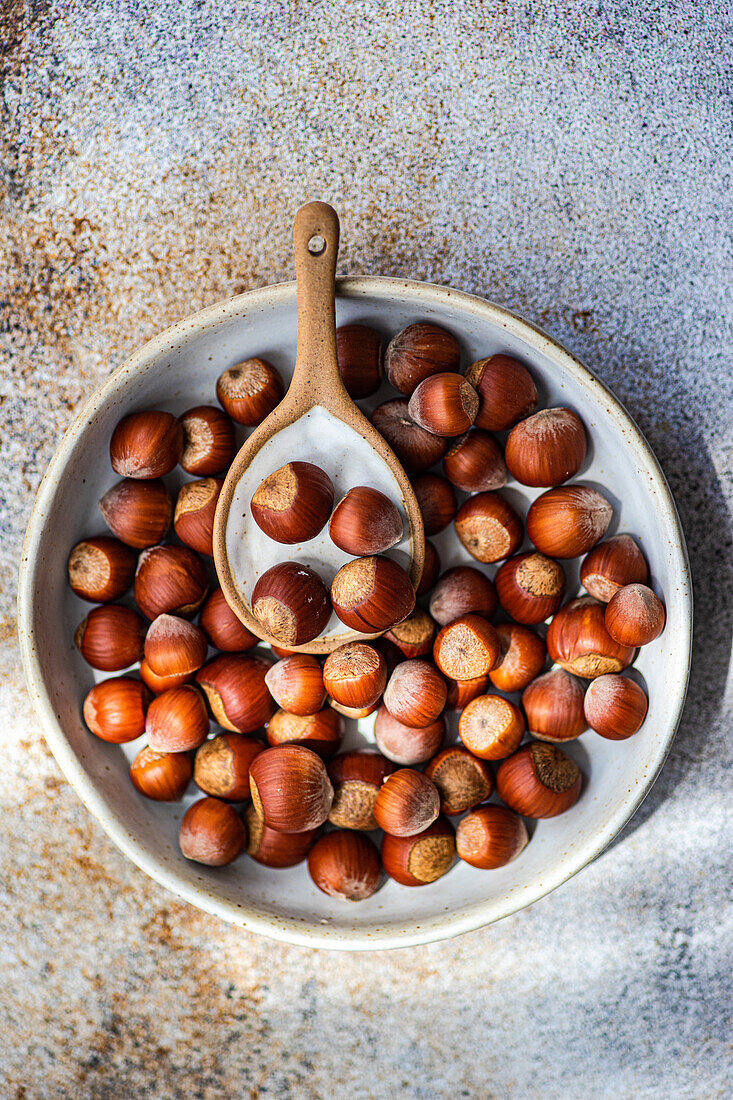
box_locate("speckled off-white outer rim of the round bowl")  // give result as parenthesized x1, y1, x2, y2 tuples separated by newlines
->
(18, 275, 692, 950)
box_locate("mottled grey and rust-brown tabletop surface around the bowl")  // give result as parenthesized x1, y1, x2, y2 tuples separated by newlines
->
(0, 0, 733, 1100)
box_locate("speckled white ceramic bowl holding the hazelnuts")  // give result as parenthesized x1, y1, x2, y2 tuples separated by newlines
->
(19, 277, 692, 949)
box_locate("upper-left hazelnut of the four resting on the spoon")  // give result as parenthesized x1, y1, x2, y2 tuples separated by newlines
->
(250, 462, 333, 546)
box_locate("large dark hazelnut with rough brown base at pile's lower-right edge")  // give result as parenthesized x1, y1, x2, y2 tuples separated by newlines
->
(496, 741, 582, 817)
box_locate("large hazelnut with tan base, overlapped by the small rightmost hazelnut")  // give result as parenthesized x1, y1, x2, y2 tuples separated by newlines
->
(547, 596, 634, 680)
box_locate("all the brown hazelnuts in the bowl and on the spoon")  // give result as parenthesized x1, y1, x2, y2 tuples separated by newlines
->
(68, 322, 665, 901)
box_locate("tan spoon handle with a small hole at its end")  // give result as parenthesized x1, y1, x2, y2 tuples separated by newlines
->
(289, 202, 343, 403)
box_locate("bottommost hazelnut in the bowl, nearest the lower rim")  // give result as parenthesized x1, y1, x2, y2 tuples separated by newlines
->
(308, 829, 382, 901)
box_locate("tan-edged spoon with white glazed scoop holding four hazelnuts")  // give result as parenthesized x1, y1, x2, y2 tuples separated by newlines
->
(214, 202, 425, 653)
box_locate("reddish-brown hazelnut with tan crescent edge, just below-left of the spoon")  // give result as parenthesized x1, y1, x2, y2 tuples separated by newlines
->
(196, 653, 276, 734)
